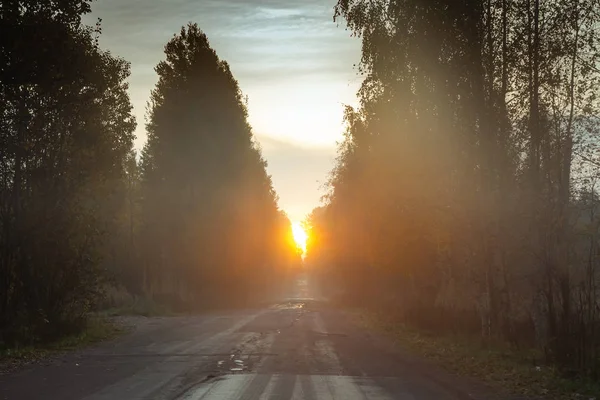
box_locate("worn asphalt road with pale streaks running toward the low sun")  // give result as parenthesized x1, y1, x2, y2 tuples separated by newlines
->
(0, 280, 506, 400)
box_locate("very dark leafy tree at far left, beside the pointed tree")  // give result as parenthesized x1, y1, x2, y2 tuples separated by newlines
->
(0, 1, 135, 342)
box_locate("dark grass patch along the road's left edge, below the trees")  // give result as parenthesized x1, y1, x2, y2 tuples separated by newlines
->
(0, 316, 127, 371)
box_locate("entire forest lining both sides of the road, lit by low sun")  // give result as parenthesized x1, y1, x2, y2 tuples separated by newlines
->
(0, 0, 600, 390)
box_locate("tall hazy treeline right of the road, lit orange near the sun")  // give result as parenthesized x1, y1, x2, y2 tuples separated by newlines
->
(307, 0, 600, 378)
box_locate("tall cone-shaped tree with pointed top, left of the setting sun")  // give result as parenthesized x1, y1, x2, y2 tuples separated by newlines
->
(141, 24, 296, 308)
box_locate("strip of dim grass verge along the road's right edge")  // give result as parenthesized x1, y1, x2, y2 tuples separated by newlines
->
(356, 309, 600, 400)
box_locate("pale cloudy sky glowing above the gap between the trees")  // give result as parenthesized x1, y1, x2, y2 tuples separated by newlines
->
(85, 0, 360, 221)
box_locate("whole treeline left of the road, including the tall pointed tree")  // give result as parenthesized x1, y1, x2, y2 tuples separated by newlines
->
(0, 0, 298, 346)
